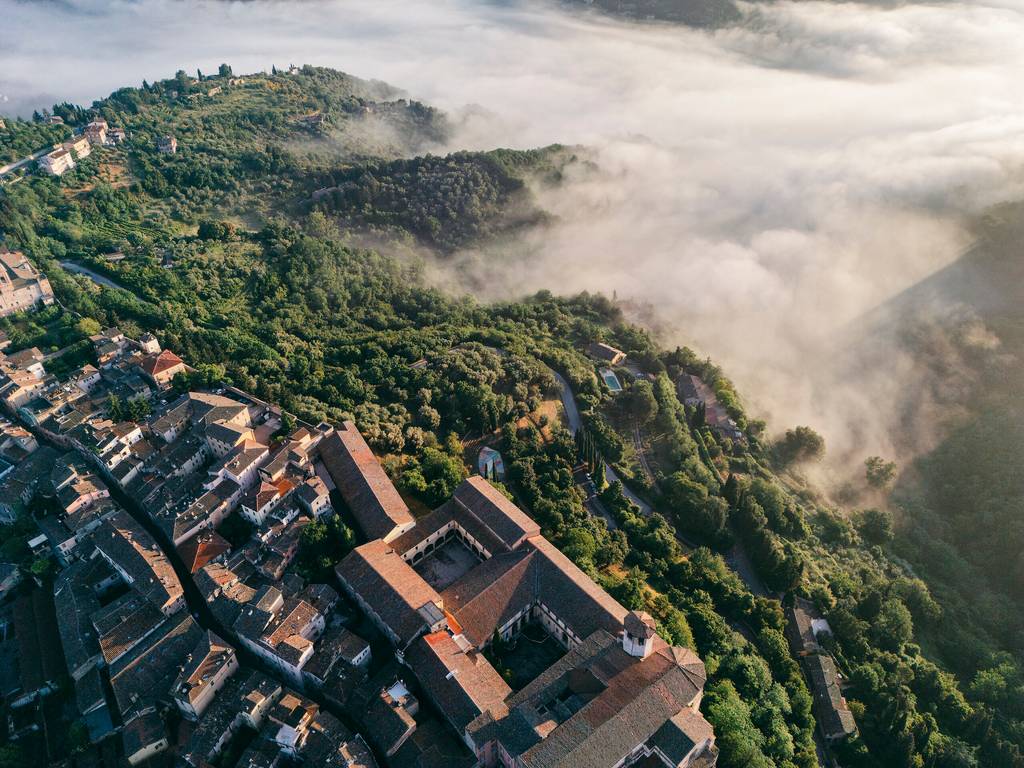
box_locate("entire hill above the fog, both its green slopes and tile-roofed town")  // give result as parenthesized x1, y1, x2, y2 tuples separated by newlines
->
(0, 65, 995, 768)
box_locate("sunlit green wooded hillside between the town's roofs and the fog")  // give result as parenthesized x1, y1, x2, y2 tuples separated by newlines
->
(0, 68, 1024, 768)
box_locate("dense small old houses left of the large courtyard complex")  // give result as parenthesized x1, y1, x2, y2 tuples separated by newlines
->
(0, 329, 376, 768)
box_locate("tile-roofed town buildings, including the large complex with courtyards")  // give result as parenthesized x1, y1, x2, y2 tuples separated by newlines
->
(0, 321, 718, 768)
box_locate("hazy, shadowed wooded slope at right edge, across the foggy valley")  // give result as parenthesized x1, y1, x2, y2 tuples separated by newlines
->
(839, 204, 1024, 753)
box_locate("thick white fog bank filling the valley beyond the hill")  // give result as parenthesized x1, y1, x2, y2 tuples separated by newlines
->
(0, 0, 1024, 481)
